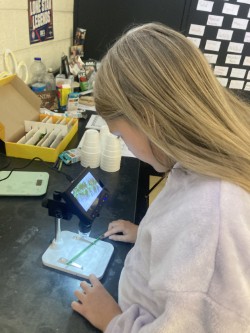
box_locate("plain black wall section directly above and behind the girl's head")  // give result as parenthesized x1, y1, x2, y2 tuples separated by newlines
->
(74, 0, 191, 60)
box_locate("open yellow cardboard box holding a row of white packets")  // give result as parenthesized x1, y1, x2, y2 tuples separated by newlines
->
(0, 75, 78, 162)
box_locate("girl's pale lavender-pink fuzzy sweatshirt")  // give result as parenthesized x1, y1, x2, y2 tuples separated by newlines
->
(105, 164, 250, 333)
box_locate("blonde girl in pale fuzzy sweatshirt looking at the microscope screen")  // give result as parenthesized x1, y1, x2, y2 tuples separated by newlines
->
(72, 23, 250, 333)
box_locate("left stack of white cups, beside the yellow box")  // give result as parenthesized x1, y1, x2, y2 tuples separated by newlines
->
(81, 129, 101, 168)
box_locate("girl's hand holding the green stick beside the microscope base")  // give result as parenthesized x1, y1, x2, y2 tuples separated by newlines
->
(104, 220, 138, 243)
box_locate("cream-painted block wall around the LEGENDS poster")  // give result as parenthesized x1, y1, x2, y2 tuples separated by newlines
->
(0, 0, 74, 82)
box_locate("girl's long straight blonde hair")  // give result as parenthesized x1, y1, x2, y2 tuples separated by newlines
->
(94, 23, 250, 191)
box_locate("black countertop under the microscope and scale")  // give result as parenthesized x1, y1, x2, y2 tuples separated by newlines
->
(0, 115, 139, 333)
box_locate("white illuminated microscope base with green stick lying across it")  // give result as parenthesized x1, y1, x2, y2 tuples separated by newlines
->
(42, 231, 114, 279)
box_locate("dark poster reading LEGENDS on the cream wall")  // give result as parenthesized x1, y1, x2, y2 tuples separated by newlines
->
(28, 0, 54, 44)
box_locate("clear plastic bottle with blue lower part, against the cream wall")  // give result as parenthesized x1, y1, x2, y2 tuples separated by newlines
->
(30, 57, 46, 92)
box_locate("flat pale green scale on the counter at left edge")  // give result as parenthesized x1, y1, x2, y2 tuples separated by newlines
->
(0, 171, 49, 196)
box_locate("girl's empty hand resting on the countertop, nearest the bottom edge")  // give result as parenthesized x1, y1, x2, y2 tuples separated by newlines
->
(71, 274, 122, 331)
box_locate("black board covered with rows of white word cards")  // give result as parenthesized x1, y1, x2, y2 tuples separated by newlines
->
(187, 0, 250, 91)
